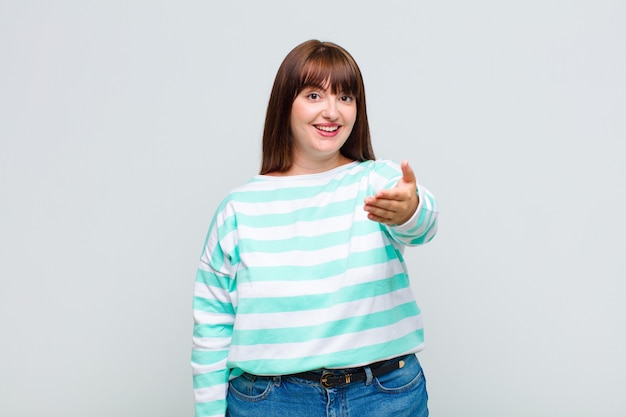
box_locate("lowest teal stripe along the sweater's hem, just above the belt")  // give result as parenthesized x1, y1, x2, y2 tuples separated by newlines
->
(235, 329, 424, 374)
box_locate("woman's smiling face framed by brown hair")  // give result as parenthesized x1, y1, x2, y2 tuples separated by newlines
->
(290, 86, 357, 161)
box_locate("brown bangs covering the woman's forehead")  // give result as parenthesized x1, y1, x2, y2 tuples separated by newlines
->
(296, 48, 361, 100)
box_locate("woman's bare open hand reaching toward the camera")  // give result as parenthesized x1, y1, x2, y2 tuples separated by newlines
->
(363, 161, 419, 226)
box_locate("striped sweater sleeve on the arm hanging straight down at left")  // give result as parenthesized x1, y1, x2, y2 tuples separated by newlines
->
(191, 204, 236, 417)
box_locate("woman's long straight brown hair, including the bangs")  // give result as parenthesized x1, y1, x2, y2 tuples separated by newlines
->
(260, 40, 375, 174)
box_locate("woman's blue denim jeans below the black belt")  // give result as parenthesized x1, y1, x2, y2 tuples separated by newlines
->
(226, 355, 428, 417)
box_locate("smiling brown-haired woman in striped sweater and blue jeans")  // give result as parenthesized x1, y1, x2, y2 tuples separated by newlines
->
(192, 40, 437, 417)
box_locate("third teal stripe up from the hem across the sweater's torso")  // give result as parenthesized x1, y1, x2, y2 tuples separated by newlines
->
(237, 274, 409, 314)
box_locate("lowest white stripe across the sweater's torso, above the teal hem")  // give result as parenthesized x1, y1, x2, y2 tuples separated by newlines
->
(229, 315, 422, 362)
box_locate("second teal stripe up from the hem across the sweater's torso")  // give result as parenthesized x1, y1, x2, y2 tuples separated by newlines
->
(232, 302, 420, 345)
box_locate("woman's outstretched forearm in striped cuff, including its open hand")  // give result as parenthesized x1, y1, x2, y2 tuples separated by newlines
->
(364, 161, 438, 245)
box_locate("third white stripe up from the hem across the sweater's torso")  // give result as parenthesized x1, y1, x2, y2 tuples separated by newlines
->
(237, 262, 406, 299)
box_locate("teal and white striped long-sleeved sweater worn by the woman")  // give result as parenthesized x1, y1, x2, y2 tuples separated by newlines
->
(192, 161, 437, 417)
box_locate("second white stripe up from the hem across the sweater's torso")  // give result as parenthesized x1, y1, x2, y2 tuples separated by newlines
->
(235, 287, 415, 331)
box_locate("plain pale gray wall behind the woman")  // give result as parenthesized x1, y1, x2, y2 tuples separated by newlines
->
(0, 0, 626, 417)
